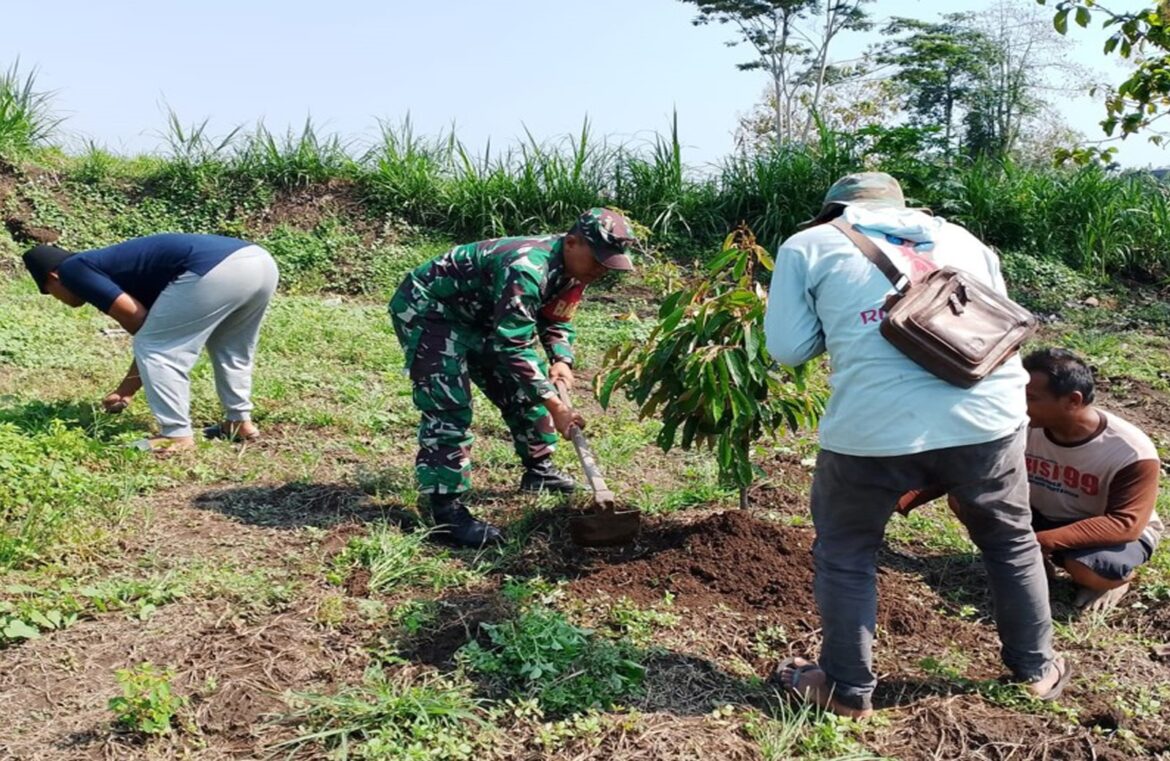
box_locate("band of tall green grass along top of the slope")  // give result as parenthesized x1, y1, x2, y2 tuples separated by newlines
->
(0, 74, 1170, 280)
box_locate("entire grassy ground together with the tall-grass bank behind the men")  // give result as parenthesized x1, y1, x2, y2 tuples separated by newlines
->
(0, 59, 1170, 761)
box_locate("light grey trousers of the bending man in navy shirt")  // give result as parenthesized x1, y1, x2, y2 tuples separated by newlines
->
(135, 246, 278, 437)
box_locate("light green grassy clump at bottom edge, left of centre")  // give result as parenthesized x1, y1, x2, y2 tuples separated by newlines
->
(274, 666, 491, 761)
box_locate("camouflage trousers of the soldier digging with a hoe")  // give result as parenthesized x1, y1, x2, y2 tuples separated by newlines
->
(390, 290, 557, 494)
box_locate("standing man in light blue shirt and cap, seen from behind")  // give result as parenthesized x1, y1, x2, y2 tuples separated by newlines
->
(765, 172, 1069, 718)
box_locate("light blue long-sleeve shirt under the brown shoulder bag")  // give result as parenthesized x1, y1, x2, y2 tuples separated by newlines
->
(764, 206, 1027, 457)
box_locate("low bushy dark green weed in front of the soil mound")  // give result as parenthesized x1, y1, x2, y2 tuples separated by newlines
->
(459, 606, 645, 715)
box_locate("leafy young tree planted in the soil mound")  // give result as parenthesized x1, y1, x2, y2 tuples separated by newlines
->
(594, 227, 824, 507)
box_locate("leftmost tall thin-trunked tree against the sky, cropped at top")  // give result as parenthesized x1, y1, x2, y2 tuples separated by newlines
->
(682, 0, 872, 143)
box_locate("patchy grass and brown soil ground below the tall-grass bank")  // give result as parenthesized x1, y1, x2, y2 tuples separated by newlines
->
(0, 244, 1170, 759)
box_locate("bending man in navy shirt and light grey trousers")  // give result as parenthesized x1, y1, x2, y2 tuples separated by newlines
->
(23, 233, 278, 451)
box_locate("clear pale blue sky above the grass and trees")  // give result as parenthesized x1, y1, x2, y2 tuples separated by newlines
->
(0, 0, 1170, 165)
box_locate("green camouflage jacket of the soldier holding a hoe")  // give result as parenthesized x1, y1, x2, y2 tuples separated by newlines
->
(404, 235, 585, 402)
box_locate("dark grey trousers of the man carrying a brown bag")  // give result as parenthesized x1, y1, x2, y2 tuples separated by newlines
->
(812, 427, 1054, 709)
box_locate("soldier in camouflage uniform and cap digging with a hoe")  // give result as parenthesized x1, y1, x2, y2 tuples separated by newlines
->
(390, 208, 634, 547)
